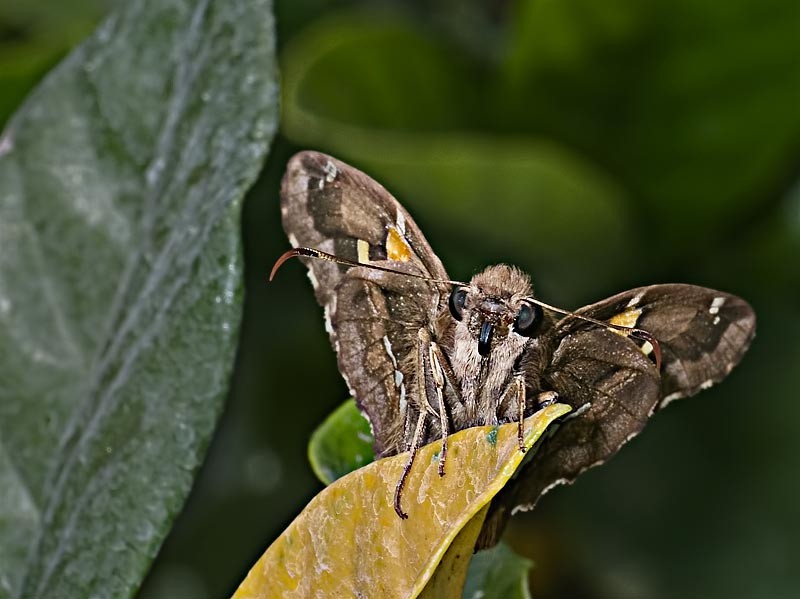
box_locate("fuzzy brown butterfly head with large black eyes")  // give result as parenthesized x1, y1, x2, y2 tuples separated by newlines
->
(449, 264, 544, 357)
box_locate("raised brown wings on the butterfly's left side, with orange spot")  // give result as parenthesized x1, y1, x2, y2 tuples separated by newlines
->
(281, 152, 447, 455)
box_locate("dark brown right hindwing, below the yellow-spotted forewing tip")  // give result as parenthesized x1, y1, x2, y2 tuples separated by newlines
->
(478, 330, 660, 548)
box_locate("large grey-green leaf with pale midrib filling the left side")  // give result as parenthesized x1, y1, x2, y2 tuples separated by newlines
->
(0, 0, 277, 598)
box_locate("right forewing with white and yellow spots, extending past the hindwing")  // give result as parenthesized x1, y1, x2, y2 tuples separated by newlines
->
(578, 284, 756, 407)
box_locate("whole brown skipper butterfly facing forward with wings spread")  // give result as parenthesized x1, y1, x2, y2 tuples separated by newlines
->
(270, 151, 755, 544)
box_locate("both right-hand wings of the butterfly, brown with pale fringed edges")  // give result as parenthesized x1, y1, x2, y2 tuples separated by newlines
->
(480, 285, 755, 547)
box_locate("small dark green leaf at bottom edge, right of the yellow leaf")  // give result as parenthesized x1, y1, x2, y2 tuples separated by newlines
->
(463, 543, 533, 599)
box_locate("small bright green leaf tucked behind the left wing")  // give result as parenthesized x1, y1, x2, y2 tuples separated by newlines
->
(308, 399, 375, 485)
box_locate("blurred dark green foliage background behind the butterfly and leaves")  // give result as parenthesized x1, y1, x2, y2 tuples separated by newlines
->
(0, 0, 800, 599)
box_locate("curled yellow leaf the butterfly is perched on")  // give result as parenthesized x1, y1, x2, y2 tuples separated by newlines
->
(234, 404, 570, 599)
